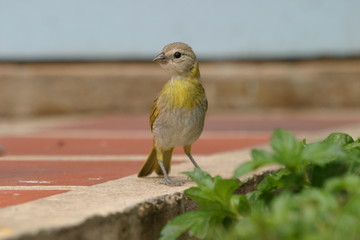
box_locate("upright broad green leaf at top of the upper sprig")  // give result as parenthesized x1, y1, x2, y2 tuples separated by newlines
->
(270, 129, 304, 170)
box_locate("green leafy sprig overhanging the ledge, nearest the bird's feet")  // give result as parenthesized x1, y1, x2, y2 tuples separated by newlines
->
(162, 169, 245, 239)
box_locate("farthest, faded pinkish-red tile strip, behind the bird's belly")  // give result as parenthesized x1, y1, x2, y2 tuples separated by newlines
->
(50, 114, 360, 131)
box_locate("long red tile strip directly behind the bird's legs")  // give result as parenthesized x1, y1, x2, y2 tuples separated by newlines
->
(0, 136, 269, 155)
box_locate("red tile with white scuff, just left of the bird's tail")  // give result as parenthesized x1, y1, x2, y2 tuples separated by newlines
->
(0, 161, 143, 186)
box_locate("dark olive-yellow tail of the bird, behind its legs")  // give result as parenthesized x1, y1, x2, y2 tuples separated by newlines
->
(138, 147, 173, 177)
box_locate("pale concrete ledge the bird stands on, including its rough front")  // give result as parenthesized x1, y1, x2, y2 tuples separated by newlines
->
(0, 147, 276, 240)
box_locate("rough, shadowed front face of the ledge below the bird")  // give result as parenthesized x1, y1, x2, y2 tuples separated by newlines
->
(15, 193, 196, 240)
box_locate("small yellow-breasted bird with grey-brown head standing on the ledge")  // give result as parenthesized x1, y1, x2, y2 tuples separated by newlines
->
(138, 42, 208, 186)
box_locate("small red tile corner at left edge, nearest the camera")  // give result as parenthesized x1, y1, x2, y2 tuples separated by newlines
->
(0, 190, 67, 207)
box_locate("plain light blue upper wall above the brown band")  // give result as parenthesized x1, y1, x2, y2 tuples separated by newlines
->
(0, 0, 360, 60)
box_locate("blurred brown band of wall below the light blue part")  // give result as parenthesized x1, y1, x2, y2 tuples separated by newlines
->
(0, 59, 360, 116)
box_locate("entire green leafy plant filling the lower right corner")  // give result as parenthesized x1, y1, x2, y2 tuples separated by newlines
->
(160, 129, 360, 240)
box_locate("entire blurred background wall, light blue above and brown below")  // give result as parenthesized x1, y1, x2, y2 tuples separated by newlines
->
(0, 0, 360, 117)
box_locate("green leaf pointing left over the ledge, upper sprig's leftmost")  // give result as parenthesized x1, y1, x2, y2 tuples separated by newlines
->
(234, 149, 275, 178)
